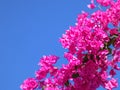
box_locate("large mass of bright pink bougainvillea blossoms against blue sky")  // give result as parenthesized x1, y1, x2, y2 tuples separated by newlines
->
(21, 0, 120, 90)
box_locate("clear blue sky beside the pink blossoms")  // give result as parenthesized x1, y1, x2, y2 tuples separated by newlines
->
(0, 0, 119, 90)
